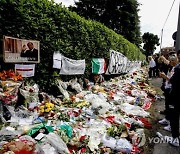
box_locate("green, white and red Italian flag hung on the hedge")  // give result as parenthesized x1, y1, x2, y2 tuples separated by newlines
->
(91, 58, 106, 74)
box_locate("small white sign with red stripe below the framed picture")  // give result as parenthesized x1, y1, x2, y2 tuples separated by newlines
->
(15, 64, 35, 77)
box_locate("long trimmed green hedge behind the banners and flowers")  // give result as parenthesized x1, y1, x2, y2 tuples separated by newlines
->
(0, 0, 145, 90)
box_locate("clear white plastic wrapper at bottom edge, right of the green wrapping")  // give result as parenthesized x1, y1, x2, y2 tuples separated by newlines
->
(46, 133, 69, 154)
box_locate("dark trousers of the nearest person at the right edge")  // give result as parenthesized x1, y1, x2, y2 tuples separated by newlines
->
(169, 104, 180, 138)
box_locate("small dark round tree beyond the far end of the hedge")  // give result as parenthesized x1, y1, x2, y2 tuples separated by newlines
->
(142, 32, 160, 57)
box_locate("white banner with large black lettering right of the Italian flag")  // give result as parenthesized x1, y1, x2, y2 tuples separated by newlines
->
(106, 50, 127, 74)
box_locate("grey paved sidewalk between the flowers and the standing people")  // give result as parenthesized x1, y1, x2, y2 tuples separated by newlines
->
(148, 78, 180, 154)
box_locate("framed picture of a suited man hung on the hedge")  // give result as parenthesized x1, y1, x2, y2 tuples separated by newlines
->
(3, 36, 40, 63)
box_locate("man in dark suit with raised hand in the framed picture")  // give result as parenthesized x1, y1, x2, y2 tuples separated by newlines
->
(21, 42, 38, 61)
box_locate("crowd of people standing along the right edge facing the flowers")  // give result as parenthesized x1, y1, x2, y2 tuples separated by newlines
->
(148, 50, 180, 147)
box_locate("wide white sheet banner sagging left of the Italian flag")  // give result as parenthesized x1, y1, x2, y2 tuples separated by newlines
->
(59, 56, 85, 75)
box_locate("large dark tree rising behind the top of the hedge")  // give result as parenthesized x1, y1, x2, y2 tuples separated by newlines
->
(69, 0, 141, 47)
